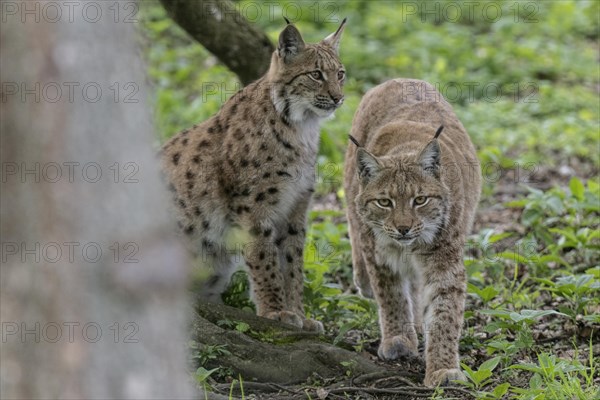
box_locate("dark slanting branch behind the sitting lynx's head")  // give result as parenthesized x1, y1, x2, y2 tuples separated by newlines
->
(160, 0, 274, 85)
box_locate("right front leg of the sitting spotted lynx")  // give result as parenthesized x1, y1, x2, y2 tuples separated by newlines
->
(277, 195, 323, 332)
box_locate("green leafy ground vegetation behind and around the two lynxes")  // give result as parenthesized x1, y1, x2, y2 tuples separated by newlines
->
(140, 1, 600, 399)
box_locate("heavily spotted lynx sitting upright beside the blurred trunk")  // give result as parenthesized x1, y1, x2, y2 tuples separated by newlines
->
(162, 20, 345, 330)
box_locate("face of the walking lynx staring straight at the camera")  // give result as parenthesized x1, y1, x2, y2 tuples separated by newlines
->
(356, 146, 448, 246)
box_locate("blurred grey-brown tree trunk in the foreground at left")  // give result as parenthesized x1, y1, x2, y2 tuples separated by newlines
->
(0, 2, 195, 399)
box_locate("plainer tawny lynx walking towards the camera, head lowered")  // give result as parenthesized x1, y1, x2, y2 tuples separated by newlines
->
(345, 79, 481, 386)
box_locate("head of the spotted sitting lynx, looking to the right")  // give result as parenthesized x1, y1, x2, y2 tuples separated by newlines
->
(270, 23, 346, 122)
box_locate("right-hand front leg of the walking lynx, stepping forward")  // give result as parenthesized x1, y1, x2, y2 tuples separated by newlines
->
(424, 264, 466, 386)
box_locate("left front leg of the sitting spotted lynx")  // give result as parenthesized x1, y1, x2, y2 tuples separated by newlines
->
(244, 226, 302, 328)
